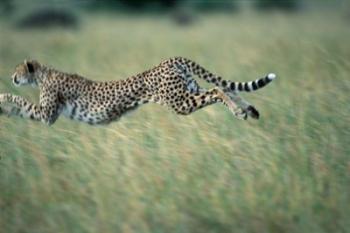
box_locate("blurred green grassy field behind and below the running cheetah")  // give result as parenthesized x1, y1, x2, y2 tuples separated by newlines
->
(0, 8, 350, 233)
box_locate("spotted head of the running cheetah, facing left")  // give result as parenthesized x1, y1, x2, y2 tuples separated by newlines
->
(12, 60, 40, 86)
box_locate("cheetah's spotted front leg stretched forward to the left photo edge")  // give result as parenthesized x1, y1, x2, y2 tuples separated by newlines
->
(0, 93, 57, 125)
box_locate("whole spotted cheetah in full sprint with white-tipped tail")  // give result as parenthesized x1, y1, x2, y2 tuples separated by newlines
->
(0, 57, 275, 125)
